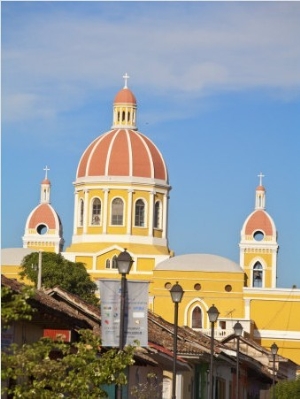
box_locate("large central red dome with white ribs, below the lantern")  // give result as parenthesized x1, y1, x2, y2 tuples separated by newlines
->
(76, 129, 168, 183)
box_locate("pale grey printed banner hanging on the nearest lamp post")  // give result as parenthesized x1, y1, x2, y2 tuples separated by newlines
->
(98, 279, 149, 347)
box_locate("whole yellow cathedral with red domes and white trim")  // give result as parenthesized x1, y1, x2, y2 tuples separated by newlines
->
(2, 74, 300, 365)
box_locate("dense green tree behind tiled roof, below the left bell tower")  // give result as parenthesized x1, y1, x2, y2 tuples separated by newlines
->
(20, 252, 99, 305)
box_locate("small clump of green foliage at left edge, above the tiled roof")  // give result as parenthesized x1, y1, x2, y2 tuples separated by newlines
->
(1, 287, 34, 328)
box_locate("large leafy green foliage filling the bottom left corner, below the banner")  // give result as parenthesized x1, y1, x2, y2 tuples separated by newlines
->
(2, 330, 134, 399)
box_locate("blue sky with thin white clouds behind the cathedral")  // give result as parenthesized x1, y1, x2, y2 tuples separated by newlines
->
(1, 1, 300, 287)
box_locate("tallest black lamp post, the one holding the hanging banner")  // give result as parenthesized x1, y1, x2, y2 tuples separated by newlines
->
(117, 248, 133, 399)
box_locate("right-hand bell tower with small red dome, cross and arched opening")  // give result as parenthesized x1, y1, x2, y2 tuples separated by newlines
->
(239, 173, 279, 289)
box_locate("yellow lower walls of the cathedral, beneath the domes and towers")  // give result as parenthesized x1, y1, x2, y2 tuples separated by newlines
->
(2, 253, 300, 364)
